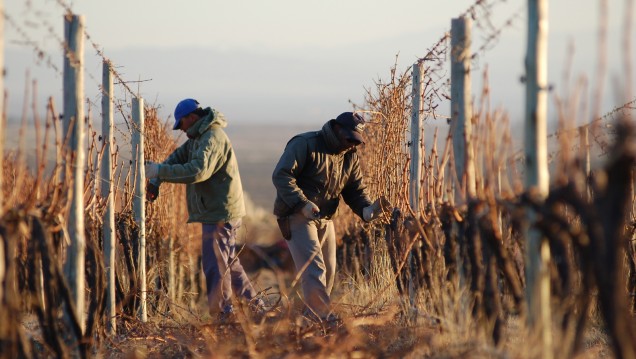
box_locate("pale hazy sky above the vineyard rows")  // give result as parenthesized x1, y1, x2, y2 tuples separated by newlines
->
(4, 0, 636, 128)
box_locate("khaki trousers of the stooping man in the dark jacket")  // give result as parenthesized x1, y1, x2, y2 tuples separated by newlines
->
(287, 213, 336, 318)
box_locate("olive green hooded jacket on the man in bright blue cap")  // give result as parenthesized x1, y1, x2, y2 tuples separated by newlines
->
(159, 107, 245, 223)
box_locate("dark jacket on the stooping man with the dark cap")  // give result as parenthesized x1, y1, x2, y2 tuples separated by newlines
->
(272, 120, 371, 218)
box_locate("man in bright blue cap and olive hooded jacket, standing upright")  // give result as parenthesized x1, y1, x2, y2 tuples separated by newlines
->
(145, 99, 263, 320)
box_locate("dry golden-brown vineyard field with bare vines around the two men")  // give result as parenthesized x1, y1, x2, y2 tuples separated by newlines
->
(0, 1, 636, 358)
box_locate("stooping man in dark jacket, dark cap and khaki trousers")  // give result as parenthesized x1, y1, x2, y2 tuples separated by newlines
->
(272, 112, 390, 321)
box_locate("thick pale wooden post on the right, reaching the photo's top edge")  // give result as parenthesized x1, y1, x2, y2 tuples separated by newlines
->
(525, 0, 553, 358)
